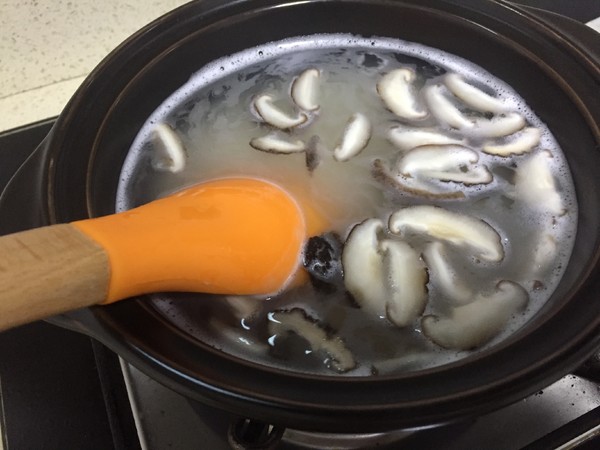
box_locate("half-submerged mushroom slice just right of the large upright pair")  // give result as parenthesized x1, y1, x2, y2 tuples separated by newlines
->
(423, 241, 473, 305)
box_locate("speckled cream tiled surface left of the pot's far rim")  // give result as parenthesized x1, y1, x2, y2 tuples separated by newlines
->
(0, 0, 186, 131)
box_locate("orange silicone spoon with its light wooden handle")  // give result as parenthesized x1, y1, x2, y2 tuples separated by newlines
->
(0, 178, 310, 330)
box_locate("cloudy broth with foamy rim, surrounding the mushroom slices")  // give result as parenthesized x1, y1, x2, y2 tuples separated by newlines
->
(117, 35, 577, 376)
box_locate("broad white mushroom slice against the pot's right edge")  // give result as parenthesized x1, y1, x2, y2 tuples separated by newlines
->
(515, 151, 566, 215)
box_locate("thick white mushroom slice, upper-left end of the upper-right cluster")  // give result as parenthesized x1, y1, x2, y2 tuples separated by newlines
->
(377, 68, 428, 120)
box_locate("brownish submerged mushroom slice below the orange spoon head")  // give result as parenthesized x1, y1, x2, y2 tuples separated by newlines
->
(268, 308, 356, 372)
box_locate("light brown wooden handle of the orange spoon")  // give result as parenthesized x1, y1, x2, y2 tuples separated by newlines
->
(0, 224, 110, 330)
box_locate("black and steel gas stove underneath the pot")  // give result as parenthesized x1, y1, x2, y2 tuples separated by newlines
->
(0, 0, 600, 450)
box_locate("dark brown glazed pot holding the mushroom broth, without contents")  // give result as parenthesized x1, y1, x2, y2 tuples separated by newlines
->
(0, 0, 600, 432)
